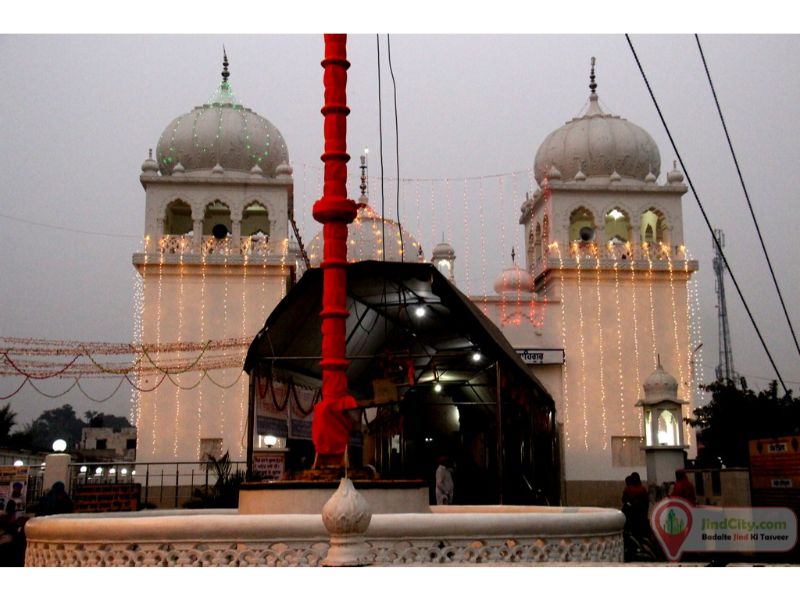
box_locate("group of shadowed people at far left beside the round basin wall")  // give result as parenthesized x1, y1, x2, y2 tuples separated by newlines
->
(0, 481, 72, 567)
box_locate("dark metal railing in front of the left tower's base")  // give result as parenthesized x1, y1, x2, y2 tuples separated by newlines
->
(69, 461, 246, 508)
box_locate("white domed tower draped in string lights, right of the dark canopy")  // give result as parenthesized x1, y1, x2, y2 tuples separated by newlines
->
(473, 61, 697, 506)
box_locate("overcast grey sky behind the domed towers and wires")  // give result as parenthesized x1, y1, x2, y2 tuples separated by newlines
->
(0, 34, 800, 423)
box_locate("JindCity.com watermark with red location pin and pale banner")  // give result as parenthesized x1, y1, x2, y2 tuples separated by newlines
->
(650, 498, 797, 560)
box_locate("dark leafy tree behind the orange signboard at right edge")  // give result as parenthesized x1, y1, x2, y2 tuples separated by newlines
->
(687, 379, 800, 467)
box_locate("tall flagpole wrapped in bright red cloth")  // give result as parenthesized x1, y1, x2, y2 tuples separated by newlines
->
(311, 34, 356, 466)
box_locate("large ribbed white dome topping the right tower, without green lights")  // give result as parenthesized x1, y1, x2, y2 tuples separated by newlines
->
(533, 74, 661, 185)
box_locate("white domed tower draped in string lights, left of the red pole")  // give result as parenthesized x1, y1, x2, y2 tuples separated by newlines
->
(133, 57, 300, 462)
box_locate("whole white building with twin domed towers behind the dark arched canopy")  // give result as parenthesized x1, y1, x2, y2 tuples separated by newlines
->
(133, 56, 697, 506)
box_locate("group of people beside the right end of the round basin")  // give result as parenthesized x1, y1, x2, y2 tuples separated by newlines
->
(622, 469, 697, 562)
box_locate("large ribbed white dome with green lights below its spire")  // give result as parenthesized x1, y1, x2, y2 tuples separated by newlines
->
(156, 63, 289, 177)
